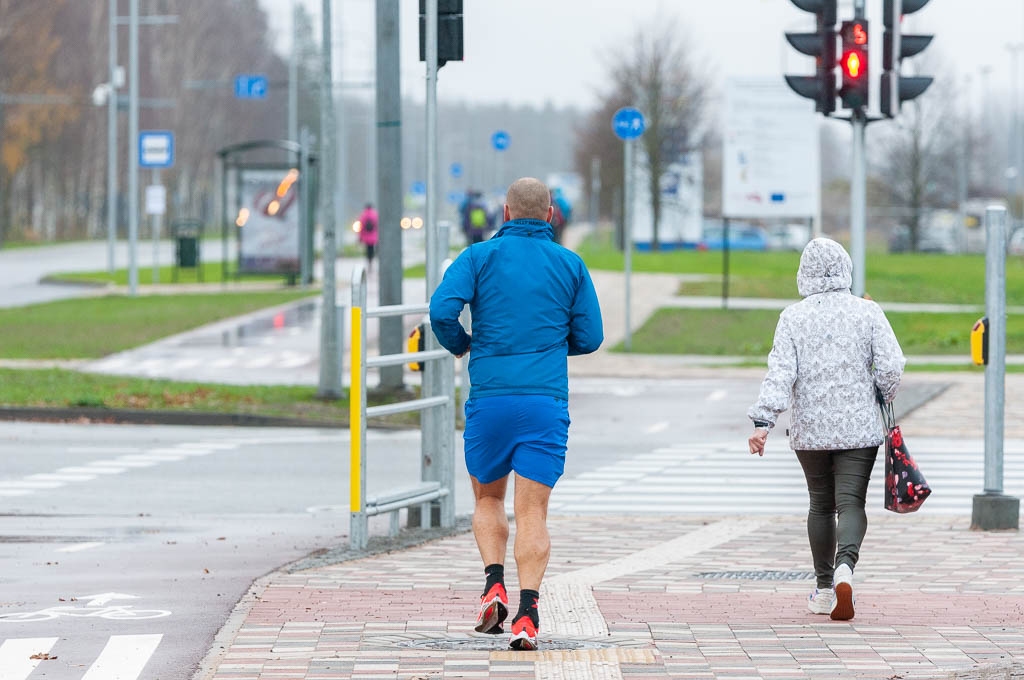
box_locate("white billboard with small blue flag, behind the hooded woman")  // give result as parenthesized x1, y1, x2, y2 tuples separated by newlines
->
(722, 78, 821, 218)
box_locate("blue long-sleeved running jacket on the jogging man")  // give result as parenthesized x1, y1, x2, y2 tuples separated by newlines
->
(430, 219, 604, 399)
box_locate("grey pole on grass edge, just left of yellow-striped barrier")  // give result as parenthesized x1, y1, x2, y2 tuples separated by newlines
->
(316, 0, 341, 399)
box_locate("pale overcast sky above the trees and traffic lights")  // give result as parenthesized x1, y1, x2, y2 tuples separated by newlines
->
(262, 0, 1024, 108)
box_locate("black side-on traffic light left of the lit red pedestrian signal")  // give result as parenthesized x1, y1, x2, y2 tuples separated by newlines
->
(785, 0, 838, 116)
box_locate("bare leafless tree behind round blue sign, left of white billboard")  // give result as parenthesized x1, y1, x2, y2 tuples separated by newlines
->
(577, 14, 708, 250)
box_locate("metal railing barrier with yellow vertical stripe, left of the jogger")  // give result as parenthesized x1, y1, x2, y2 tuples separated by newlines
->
(349, 266, 455, 550)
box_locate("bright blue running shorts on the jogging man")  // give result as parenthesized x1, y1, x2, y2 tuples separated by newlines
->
(464, 394, 569, 487)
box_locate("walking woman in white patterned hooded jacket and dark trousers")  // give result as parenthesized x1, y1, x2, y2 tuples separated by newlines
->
(746, 239, 905, 621)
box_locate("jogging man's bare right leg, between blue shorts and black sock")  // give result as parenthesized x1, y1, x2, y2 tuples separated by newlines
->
(514, 475, 551, 591)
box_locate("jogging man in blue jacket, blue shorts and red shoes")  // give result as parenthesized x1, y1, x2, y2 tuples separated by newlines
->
(430, 177, 604, 649)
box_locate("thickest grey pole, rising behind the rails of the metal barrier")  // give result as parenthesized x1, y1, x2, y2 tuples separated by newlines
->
(377, 0, 406, 390)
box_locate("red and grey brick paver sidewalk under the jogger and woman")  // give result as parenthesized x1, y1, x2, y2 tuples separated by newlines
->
(193, 513, 1024, 680)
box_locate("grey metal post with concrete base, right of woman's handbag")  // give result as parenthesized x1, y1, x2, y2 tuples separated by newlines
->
(971, 206, 1020, 530)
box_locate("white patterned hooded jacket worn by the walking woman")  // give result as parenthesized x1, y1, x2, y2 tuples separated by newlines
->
(746, 239, 906, 451)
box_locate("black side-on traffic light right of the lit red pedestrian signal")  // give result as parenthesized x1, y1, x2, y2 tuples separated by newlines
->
(881, 0, 935, 118)
